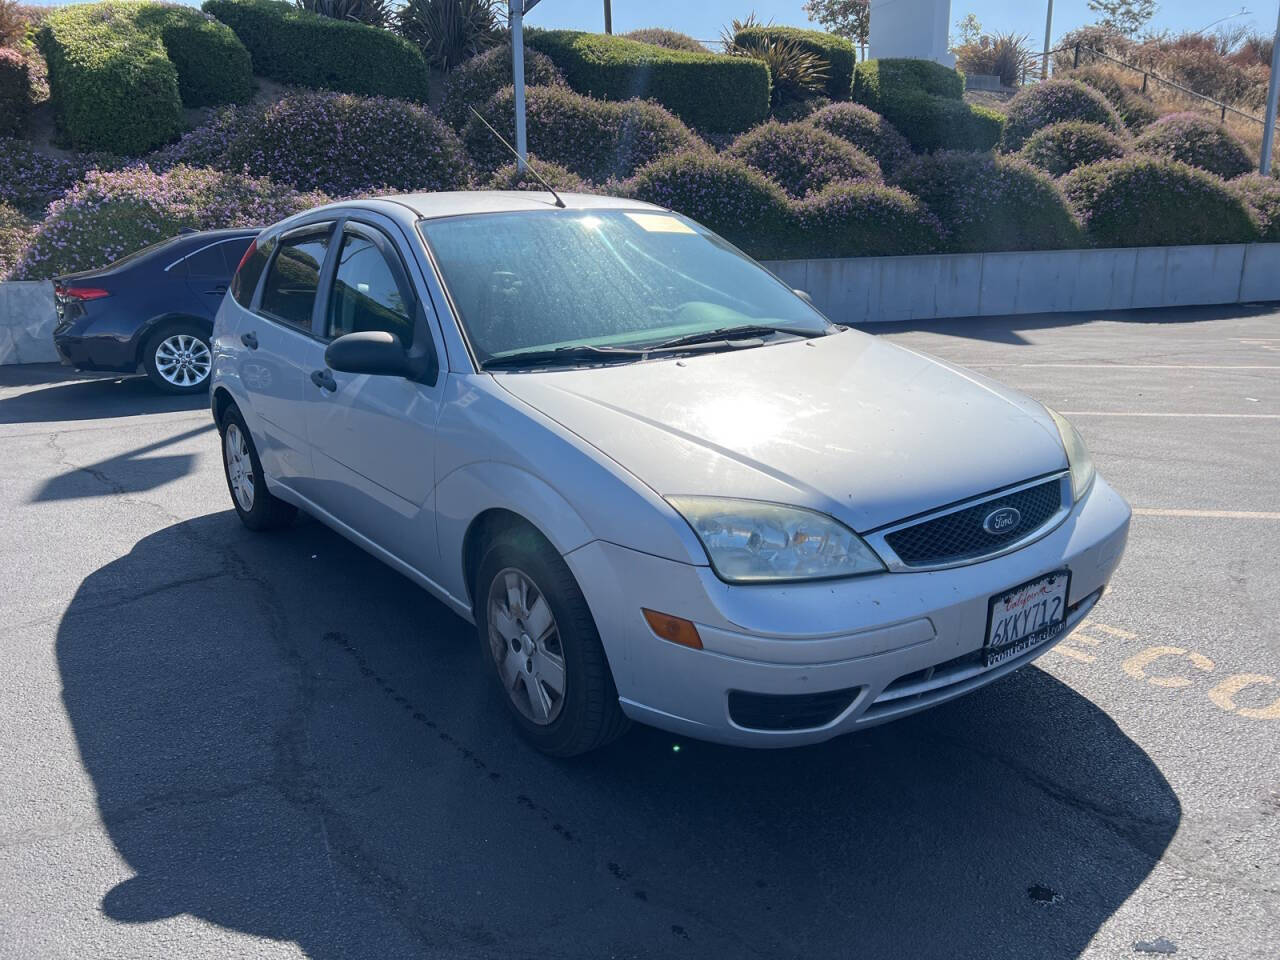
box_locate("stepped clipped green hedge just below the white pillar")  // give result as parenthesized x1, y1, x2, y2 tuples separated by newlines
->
(854, 59, 1005, 151)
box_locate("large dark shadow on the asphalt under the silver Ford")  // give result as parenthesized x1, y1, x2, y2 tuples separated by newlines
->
(58, 511, 1181, 960)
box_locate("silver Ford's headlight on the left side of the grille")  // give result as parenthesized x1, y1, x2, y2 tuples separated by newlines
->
(667, 497, 884, 584)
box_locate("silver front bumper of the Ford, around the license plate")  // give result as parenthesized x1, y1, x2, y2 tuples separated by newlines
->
(566, 477, 1130, 746)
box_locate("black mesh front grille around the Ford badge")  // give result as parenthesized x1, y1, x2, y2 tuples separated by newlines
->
(884, 477, 1062, 567)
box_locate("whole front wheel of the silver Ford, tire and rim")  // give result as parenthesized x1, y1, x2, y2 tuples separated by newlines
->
(474, 529, 627, 756)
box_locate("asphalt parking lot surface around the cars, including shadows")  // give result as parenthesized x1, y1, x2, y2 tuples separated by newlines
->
(0, 307, 1280, 960)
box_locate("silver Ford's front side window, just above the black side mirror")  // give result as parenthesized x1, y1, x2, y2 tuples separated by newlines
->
(325, 229, 413, 348)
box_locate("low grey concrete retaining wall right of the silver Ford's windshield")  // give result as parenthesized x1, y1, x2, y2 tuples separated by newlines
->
(765, 243, 1280, 324)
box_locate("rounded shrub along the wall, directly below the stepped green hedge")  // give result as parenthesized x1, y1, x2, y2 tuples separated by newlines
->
(897, 151, 1080, 253)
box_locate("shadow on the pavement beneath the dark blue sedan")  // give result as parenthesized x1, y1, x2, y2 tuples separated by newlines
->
(0, 365, 209, 424)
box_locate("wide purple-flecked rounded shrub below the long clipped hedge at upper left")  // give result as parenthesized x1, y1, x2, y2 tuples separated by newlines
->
(220, 92, 471, 196)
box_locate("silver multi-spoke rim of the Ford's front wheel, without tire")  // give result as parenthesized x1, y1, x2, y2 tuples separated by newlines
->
(488, 567, 566, 727)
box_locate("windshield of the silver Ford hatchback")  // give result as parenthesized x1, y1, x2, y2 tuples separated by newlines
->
(420, 210, 828, 364)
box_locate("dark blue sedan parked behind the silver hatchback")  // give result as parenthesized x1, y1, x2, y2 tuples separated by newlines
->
(54, 228, 259, 393)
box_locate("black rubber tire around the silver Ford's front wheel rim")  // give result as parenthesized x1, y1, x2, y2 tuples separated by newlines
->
(472, 527, 630, 756)
